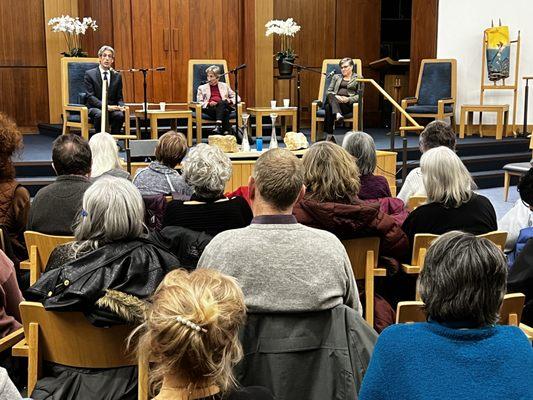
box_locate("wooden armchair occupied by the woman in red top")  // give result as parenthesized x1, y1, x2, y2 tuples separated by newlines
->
(187, 60, 246, 144)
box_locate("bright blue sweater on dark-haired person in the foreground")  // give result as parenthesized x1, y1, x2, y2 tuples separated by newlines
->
(359, 322, 533, 400)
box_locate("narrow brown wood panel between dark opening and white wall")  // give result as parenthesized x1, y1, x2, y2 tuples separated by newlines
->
(409, 0, 439, 96)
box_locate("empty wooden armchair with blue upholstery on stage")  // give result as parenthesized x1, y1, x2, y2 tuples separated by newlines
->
(401, 59, 457, 136)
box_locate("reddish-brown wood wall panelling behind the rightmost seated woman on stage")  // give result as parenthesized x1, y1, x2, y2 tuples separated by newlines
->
(274, 0, 381, 124)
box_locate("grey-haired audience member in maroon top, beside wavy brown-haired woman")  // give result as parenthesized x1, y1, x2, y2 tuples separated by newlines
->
(342, 132, 391, 200)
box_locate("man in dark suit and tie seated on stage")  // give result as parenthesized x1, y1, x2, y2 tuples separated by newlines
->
(84, 46, 124, 134)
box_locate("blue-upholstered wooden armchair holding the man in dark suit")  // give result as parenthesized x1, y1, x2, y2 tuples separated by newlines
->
(61, 57, 138, 146)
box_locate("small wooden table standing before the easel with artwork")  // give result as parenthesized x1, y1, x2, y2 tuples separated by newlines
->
(459, 104, 509, 140)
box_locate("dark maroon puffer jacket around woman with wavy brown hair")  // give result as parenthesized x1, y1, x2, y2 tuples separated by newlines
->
(293, 198, 409, 266)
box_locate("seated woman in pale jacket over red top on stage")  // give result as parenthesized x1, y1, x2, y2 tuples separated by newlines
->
(196, 65, 236, 135)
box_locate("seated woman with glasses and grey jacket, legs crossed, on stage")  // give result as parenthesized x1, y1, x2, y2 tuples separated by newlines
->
(324, 57, 359, 135)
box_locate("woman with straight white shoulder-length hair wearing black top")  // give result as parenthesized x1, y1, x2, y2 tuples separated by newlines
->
(402, 146, 498, 252)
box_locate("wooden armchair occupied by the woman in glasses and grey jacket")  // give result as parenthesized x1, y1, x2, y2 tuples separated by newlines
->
(311, 58, 363, 143)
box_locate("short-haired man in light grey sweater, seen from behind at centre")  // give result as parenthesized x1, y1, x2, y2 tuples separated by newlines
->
(198, 149, 362, 314)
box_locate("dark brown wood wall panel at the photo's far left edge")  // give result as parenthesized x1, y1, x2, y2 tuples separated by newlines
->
(0, 0, 49, 130)
